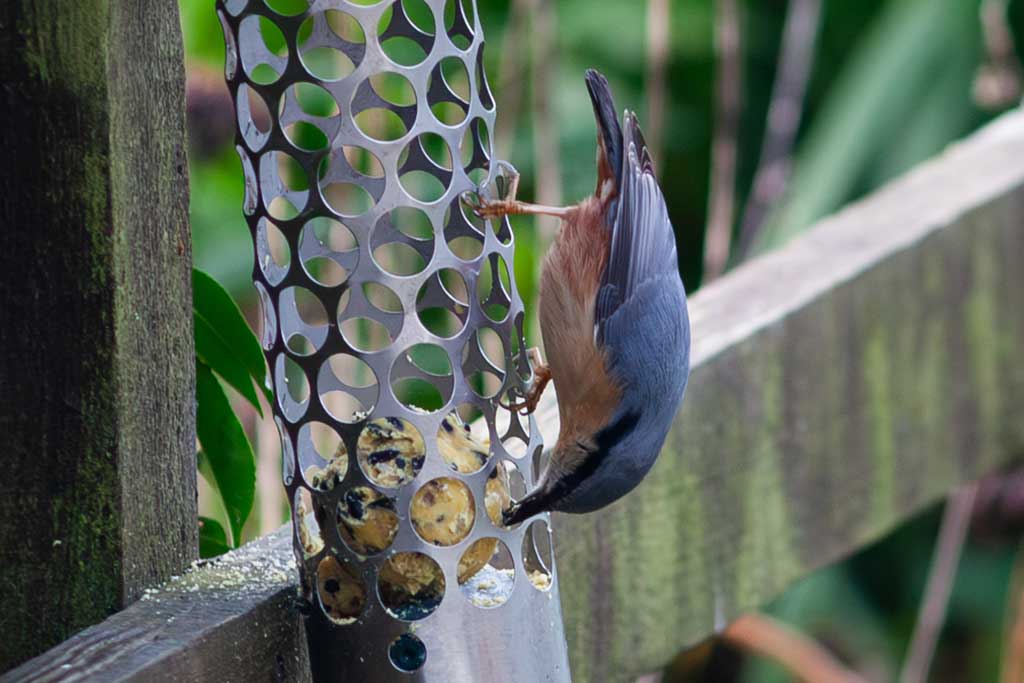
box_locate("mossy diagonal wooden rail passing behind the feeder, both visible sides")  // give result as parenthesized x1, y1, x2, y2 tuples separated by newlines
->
(3, 109, 1024, 681)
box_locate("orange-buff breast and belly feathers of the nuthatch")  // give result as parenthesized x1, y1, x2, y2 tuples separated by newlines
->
(540, 199, 620, 443)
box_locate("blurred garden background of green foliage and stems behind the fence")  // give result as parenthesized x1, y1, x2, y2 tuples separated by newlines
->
(180, 0, 1024, 682)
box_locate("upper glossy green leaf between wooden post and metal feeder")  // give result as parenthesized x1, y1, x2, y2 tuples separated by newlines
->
(193, 268, 272, 417)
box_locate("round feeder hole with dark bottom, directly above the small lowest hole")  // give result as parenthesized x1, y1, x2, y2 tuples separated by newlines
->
(377, 553, 444, 622)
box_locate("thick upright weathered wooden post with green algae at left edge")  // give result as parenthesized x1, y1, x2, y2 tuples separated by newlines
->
(0, 0, 197, 670)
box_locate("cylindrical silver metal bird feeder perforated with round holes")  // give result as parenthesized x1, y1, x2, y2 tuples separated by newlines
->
(217, 0, 569, 681)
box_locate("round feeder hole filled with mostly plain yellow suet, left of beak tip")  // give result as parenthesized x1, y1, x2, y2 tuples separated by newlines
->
(410, 477, 476, 547)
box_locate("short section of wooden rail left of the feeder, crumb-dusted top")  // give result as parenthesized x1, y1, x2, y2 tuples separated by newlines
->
(0, 528, 309, 683)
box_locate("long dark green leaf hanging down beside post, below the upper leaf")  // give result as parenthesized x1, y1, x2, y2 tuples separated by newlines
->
(196, 359, 256, 543)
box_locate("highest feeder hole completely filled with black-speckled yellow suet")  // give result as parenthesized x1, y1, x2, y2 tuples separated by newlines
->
(356, 418, 427, 488)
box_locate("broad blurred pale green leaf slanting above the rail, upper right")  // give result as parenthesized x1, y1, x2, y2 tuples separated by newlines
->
(755, 0, 978, 252)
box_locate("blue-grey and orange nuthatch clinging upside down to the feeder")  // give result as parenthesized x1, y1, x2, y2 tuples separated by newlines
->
(468, 70, 690, 524)
